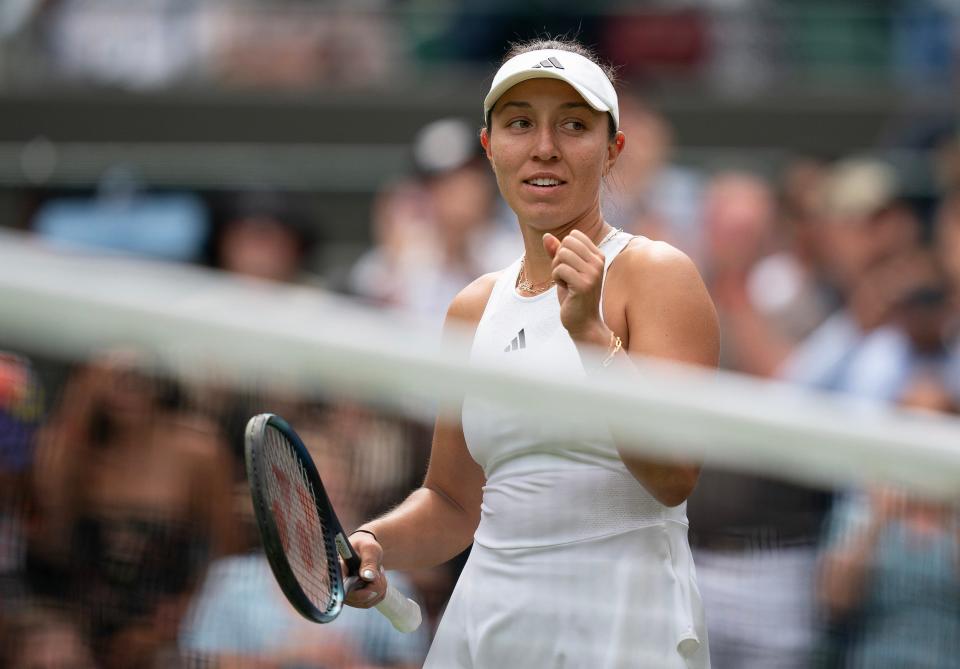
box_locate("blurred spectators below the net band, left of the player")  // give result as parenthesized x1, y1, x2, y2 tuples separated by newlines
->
(0, 349, 438, 669)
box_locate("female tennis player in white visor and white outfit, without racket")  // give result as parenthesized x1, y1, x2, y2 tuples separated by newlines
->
(348, 41, 719, 669)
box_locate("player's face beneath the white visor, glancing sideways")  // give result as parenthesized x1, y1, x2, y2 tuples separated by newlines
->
(482, 79, 623, 231)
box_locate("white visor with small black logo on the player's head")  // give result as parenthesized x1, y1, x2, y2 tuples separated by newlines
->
(483, 49, 620, 130)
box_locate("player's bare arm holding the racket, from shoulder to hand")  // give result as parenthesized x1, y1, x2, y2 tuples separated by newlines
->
(347, 274, 496, 608)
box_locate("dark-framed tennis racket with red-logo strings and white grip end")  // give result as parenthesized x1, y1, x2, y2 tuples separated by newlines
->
(245, 413, 420, 632)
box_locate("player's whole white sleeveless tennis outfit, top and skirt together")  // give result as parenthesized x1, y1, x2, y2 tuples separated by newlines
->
(424, 232, 710, 669)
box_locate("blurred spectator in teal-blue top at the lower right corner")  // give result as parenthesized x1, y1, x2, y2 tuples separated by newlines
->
(818, 372, 960, 669)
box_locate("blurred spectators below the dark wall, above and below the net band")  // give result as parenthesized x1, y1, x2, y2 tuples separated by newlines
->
(0, 44, 960, 669)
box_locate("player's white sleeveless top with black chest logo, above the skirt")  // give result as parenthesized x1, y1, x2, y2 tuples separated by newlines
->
(462, 232, 687, 549)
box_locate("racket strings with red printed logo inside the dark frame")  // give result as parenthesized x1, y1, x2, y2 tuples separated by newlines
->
(262, 427, 338, 611)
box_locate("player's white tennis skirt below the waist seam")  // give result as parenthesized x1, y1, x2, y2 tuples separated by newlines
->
(424, 522, 710, 669)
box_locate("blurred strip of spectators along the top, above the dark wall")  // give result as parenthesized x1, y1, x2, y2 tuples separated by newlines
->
(0, 0, 960, 92)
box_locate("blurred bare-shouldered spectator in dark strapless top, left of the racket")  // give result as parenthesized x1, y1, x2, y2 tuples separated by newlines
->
(28, 350, 233, 669)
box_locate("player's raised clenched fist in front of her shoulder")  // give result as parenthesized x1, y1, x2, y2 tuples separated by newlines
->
(543, 230, 609, 346)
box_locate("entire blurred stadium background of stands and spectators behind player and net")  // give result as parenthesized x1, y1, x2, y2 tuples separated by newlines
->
(0, 0, 960, 669)
